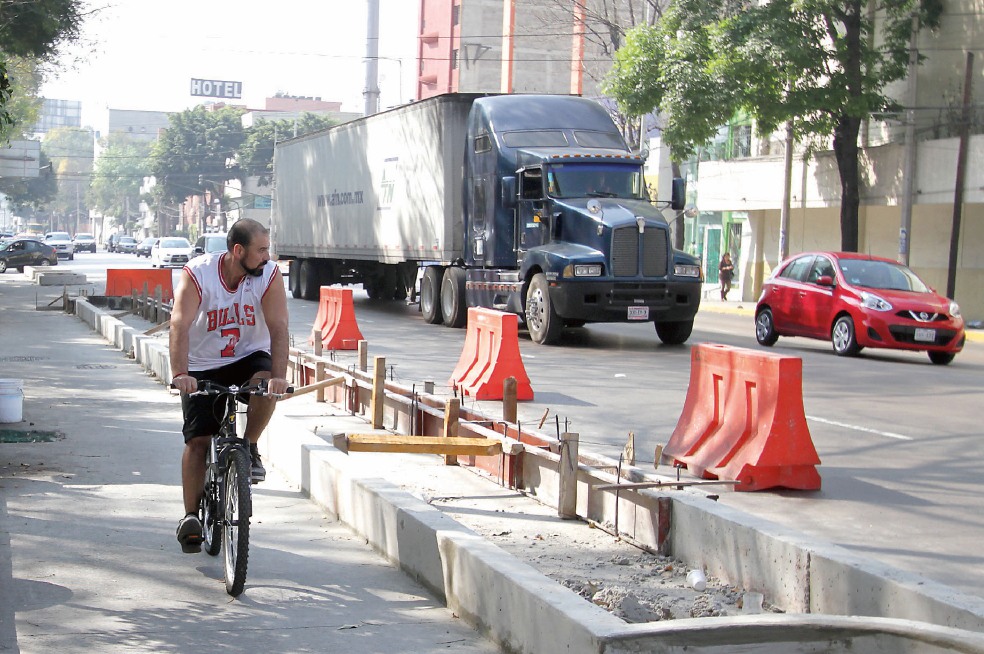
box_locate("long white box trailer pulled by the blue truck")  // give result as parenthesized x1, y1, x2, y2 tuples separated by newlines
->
(271, 95, 475, 300)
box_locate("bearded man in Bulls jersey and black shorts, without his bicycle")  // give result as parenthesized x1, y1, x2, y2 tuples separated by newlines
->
(170, 219, 289, 553)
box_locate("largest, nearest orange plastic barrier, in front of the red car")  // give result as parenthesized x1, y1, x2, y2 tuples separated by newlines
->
(663, 343, 820, 491)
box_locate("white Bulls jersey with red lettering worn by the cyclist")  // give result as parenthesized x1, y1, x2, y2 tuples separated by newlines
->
(182, 252, 277, 371)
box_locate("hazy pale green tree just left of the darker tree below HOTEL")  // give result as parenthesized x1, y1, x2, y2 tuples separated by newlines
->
(86, 133, 150, 226)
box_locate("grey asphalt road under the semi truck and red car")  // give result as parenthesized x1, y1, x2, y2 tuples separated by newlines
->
(70, 253, 984, 596)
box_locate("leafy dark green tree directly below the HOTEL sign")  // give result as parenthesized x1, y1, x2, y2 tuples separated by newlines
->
(150, 106, 245, 231)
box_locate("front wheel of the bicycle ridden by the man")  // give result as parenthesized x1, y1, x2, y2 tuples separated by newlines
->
(222, 449, 253, 597)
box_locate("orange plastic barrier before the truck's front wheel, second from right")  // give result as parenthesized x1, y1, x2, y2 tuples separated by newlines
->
(449, 307, 533, 400)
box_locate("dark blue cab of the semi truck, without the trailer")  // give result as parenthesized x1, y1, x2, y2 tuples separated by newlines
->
(454, 95, 702, 344)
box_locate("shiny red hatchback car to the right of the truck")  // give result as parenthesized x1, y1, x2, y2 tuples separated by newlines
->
(755, 252, 966, 365)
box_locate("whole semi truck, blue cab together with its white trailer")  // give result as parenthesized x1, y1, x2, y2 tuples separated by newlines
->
(271, 94, 702, 344)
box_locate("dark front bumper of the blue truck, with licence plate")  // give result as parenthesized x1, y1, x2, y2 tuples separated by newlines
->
(550, 281, 701, 322)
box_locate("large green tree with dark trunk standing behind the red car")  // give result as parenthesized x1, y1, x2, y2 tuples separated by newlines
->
(606, 0, 942, 251)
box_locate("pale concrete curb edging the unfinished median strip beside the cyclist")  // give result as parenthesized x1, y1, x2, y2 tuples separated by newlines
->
(76, 299, 984, 654)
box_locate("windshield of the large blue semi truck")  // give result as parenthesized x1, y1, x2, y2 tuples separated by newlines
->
(547, 163, 648, 200)
